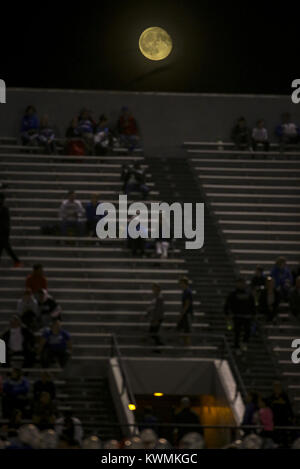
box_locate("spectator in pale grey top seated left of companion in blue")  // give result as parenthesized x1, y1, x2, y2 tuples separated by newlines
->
(59, 191, 85, 236)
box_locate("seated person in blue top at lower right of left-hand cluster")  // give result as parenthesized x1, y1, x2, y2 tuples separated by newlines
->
(39, 319, 72, 368)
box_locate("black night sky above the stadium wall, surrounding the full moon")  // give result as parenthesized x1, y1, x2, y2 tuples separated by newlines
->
(0, 0, 300, 94)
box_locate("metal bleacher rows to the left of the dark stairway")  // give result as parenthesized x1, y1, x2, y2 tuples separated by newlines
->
(0, 138, 217, 437)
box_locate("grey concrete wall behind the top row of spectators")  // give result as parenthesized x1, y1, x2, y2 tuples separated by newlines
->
(0, 88, 300, 156)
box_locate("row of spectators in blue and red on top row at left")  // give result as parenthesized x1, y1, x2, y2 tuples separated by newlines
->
(21, 105, 140, 156)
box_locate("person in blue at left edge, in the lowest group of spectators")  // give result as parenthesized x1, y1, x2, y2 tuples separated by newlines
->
(2, 368, 29, 418)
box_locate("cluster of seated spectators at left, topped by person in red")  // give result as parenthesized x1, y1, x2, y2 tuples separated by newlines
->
(2, 264, 72, 368)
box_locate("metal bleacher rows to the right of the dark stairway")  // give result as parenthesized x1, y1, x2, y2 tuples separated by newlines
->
(184, 142, 300, 415)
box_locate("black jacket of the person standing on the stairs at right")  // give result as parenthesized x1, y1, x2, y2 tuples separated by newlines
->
(224, 288, 255, 317)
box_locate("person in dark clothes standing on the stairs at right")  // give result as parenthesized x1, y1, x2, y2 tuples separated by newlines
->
(224, 278, 255, 354)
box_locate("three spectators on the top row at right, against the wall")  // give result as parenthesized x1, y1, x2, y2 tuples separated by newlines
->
(231, 112, 300, 152)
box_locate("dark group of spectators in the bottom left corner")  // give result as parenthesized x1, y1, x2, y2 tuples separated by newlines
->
(0, 368, 83, 449)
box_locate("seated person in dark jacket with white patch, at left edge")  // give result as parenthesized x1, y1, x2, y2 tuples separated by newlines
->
(2, 315, 35, 368)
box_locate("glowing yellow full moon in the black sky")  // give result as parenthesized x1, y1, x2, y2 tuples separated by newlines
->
(139, 26, 173, 60)
